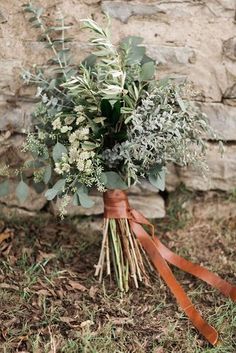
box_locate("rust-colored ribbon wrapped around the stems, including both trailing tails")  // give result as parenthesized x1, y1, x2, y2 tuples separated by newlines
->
(104, 190, 236, 345)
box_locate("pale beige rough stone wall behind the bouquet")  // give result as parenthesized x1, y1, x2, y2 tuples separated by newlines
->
(0, 0, 236, 216)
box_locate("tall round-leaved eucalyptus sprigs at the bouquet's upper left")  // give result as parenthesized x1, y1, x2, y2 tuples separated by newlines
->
(22, 2, 77, 114)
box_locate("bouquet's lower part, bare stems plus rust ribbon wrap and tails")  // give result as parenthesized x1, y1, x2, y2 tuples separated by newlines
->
(95, 189, 236, 345)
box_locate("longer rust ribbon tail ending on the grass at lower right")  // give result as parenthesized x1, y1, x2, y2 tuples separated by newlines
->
(129, 220, 218, 345)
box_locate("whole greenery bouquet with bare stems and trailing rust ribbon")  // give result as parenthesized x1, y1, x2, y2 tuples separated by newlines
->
(1, 3, 236, 344)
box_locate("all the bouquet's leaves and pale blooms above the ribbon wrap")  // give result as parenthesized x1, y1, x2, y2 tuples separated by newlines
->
(0, 2, 217, 209)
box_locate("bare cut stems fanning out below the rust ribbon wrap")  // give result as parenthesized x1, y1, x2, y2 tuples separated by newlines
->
(95, 218, 152, 292)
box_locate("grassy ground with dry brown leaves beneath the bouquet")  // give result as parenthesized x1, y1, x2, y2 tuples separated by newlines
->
(0, 190, 236, 353)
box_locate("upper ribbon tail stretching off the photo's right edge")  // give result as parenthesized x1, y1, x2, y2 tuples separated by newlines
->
(153, 237, 236, 301)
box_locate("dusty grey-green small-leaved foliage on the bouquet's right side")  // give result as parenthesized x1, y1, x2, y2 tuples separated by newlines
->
(103, 81, 215, 186)
